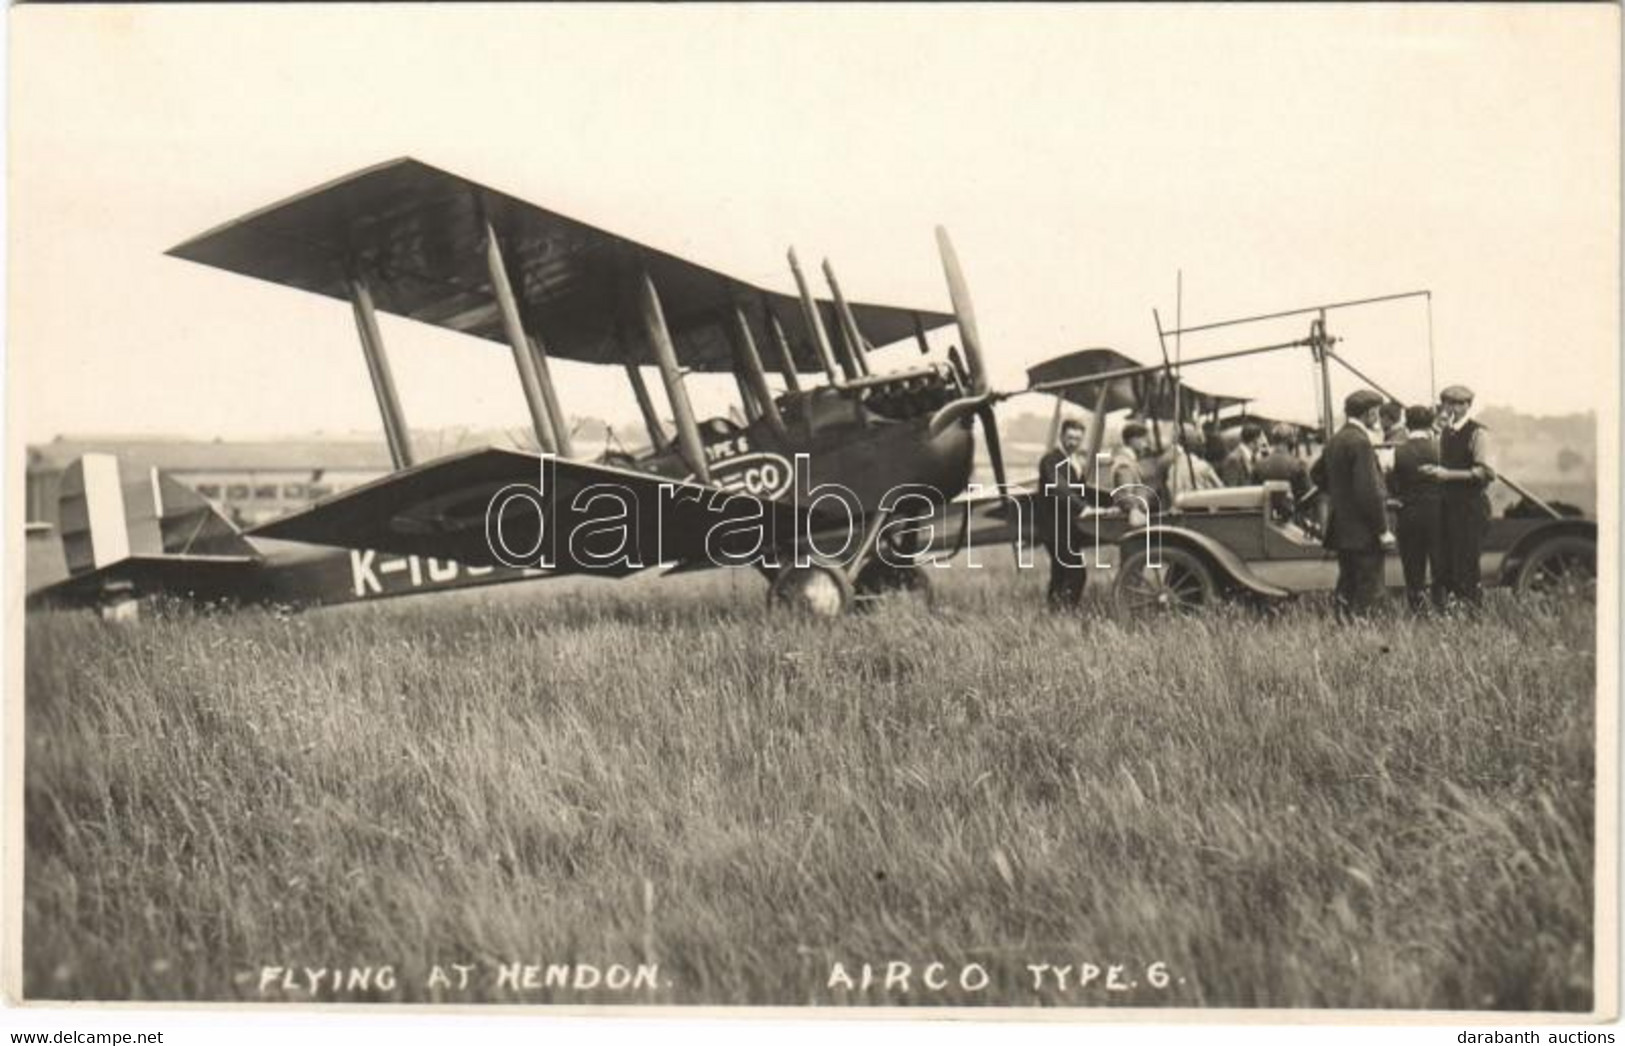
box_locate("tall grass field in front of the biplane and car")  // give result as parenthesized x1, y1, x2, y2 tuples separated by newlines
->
(24, 568, 1596, 1010)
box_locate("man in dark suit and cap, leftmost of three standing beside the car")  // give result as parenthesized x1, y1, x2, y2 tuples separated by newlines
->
(1316, 388, 1394, 619)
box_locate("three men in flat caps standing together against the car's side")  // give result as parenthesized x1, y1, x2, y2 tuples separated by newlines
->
(1313, 385, 1495, 614)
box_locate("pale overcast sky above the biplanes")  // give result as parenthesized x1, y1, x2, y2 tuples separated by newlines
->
(8, 5, 1620, 440)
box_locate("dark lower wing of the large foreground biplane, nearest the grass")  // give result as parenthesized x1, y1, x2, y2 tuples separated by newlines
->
(252, 448, 800, 577)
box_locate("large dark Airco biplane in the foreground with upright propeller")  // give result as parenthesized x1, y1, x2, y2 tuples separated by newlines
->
(31, 159, 1027, 611)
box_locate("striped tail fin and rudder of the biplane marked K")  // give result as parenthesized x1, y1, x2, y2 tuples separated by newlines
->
(57, 453, 255, 577)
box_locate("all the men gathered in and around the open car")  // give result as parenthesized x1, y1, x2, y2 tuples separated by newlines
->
(1035, 385, 1495, 616)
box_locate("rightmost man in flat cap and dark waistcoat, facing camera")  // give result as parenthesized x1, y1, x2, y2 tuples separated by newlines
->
(1422, 385, 1495, 609)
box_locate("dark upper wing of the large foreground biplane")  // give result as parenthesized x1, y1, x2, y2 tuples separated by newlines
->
(169, 159, 952, 372)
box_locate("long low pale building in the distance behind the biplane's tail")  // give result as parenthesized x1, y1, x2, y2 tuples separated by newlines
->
(24, 437, 390, 526)
